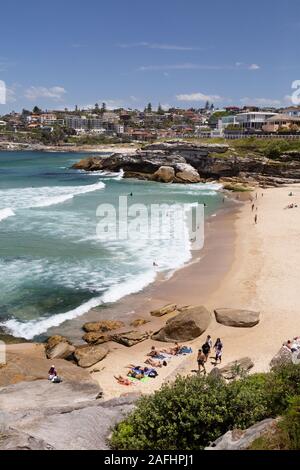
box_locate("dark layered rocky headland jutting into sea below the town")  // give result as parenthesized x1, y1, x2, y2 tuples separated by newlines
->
(73, 142, 300, 189)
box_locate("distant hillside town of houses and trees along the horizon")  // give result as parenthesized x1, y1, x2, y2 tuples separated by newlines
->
(0, 102, 300, 146)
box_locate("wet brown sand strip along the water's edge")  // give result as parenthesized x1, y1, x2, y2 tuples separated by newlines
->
(45, 198, 242, 344)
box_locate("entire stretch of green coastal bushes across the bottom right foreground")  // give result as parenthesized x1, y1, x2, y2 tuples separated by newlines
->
(111, 364, 300, 450)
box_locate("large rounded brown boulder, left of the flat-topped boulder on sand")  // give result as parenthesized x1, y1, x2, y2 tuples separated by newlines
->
(152, 306, 211, 342)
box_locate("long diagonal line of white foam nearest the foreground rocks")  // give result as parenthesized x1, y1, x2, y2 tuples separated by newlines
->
(0, 271, 155, 339)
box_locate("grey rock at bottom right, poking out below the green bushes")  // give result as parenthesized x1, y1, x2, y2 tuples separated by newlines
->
(205, 418, 277, 450)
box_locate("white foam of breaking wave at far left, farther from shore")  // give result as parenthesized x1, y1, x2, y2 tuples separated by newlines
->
(0, 181, 105, 210)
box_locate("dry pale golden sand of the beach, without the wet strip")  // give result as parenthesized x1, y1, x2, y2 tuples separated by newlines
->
(84, 185, 300, 398)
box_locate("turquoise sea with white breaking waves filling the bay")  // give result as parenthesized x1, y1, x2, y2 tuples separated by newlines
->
(0, 152, 222, 339)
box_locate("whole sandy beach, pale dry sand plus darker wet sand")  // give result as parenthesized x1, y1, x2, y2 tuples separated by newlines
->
(4, 185, 300, 399)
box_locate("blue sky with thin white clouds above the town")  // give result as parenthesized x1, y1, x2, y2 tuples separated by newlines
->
(0, 0, 300, 114)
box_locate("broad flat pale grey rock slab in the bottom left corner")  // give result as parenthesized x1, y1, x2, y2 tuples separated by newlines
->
(0, 380, 140, 450)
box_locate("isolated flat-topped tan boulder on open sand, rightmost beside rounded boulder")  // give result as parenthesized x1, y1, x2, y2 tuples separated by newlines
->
(215, 308, 260, 328)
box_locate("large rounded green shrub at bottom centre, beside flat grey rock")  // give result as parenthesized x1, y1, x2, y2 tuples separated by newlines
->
(111, 376, 230, 450)
